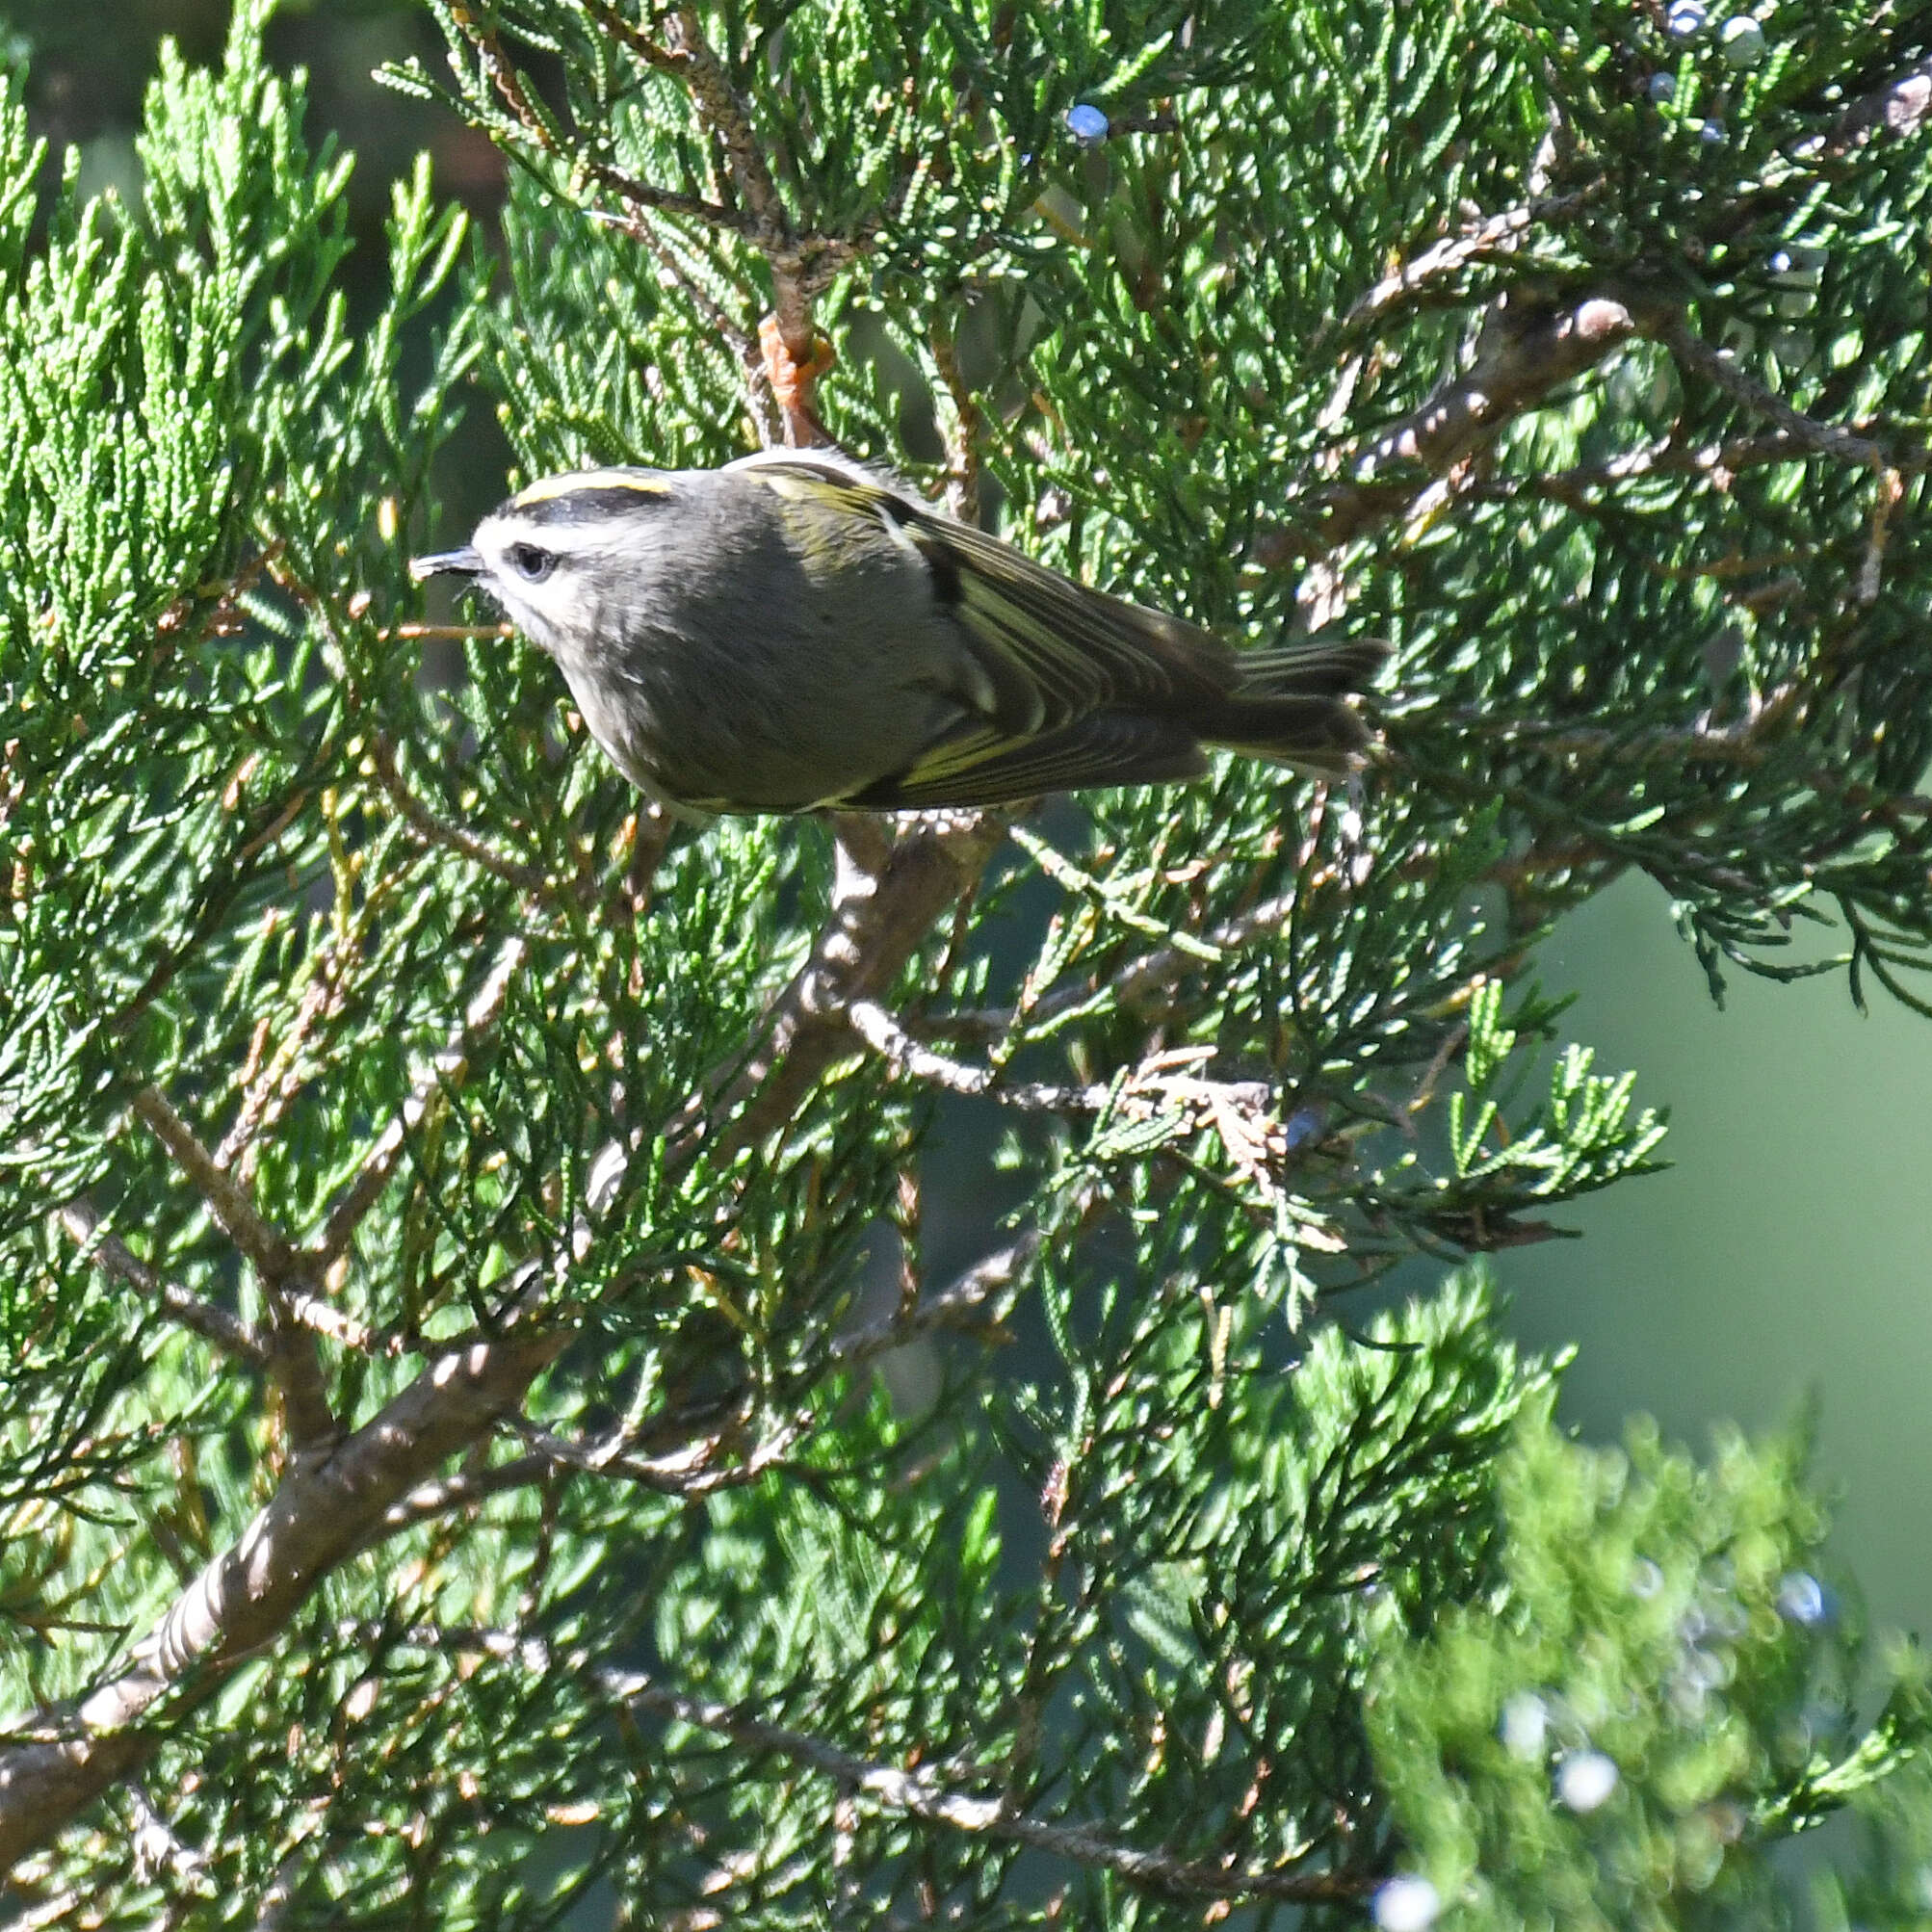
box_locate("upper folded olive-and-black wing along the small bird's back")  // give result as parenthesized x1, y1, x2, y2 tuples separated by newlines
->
(742, 456, 1233, 734)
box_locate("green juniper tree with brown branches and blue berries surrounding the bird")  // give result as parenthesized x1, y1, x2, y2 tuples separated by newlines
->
(0, 0, 1932, 1928)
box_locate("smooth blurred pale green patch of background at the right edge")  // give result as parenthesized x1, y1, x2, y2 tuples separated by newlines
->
(1498, 879, 1932, 1631)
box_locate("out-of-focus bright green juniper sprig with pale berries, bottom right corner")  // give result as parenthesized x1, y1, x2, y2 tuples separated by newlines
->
(1368, 1414, 1924, 1926)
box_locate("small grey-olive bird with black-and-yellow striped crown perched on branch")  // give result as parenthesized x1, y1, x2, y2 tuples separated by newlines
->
(409, 450, 1387, 812)
